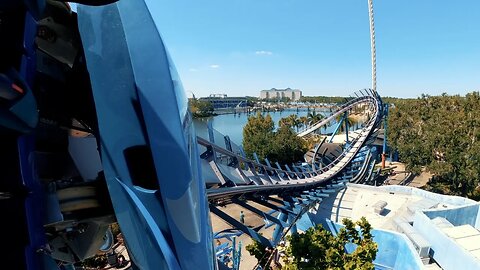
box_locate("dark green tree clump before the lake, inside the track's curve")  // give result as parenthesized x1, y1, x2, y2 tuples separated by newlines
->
(243, 112, 308, 164)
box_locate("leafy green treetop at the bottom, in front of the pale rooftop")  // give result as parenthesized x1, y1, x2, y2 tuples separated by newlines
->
(284, 217, 378, 270)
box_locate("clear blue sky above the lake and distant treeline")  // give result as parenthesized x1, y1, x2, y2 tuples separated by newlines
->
(148, 0, 480, 97)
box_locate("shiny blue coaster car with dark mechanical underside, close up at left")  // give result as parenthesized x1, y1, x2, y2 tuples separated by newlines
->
(0, 0, 217, 270)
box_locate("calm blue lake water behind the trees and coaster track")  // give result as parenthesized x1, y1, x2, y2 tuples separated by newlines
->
(194, 110, 335, 145)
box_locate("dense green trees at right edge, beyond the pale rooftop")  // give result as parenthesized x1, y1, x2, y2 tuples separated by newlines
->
(388, 92, 480, 199)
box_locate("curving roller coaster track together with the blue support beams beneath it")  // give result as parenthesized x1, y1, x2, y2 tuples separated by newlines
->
(201, 90, 383, 266)
